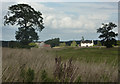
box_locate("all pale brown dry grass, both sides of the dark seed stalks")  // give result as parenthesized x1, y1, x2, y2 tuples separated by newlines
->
(2, 48, 118, 82)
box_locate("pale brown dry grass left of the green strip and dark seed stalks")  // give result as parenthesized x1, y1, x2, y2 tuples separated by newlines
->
(2, 48, 54, 82)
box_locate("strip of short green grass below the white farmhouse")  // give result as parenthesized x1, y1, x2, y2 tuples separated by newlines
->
(55, 48, 118, 65)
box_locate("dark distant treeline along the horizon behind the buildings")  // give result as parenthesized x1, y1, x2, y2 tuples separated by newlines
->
(0, 38, 120, 48)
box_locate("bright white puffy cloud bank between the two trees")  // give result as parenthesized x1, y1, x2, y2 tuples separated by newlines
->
(44, 15, 109, 31)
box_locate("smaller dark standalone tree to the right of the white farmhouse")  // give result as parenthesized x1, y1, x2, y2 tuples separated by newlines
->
(97, 22, 118, 48)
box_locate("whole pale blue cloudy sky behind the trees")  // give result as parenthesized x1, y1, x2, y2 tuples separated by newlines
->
(0, 0, 118, 41)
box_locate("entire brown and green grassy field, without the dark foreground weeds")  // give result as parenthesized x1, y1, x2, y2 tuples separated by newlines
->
(2, 48, 118, 82)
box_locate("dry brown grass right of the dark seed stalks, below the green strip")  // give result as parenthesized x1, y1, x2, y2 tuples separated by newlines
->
(75, 61, 118, 82)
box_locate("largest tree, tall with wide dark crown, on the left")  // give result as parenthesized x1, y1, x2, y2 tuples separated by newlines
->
(4, 4, 44, 45)
